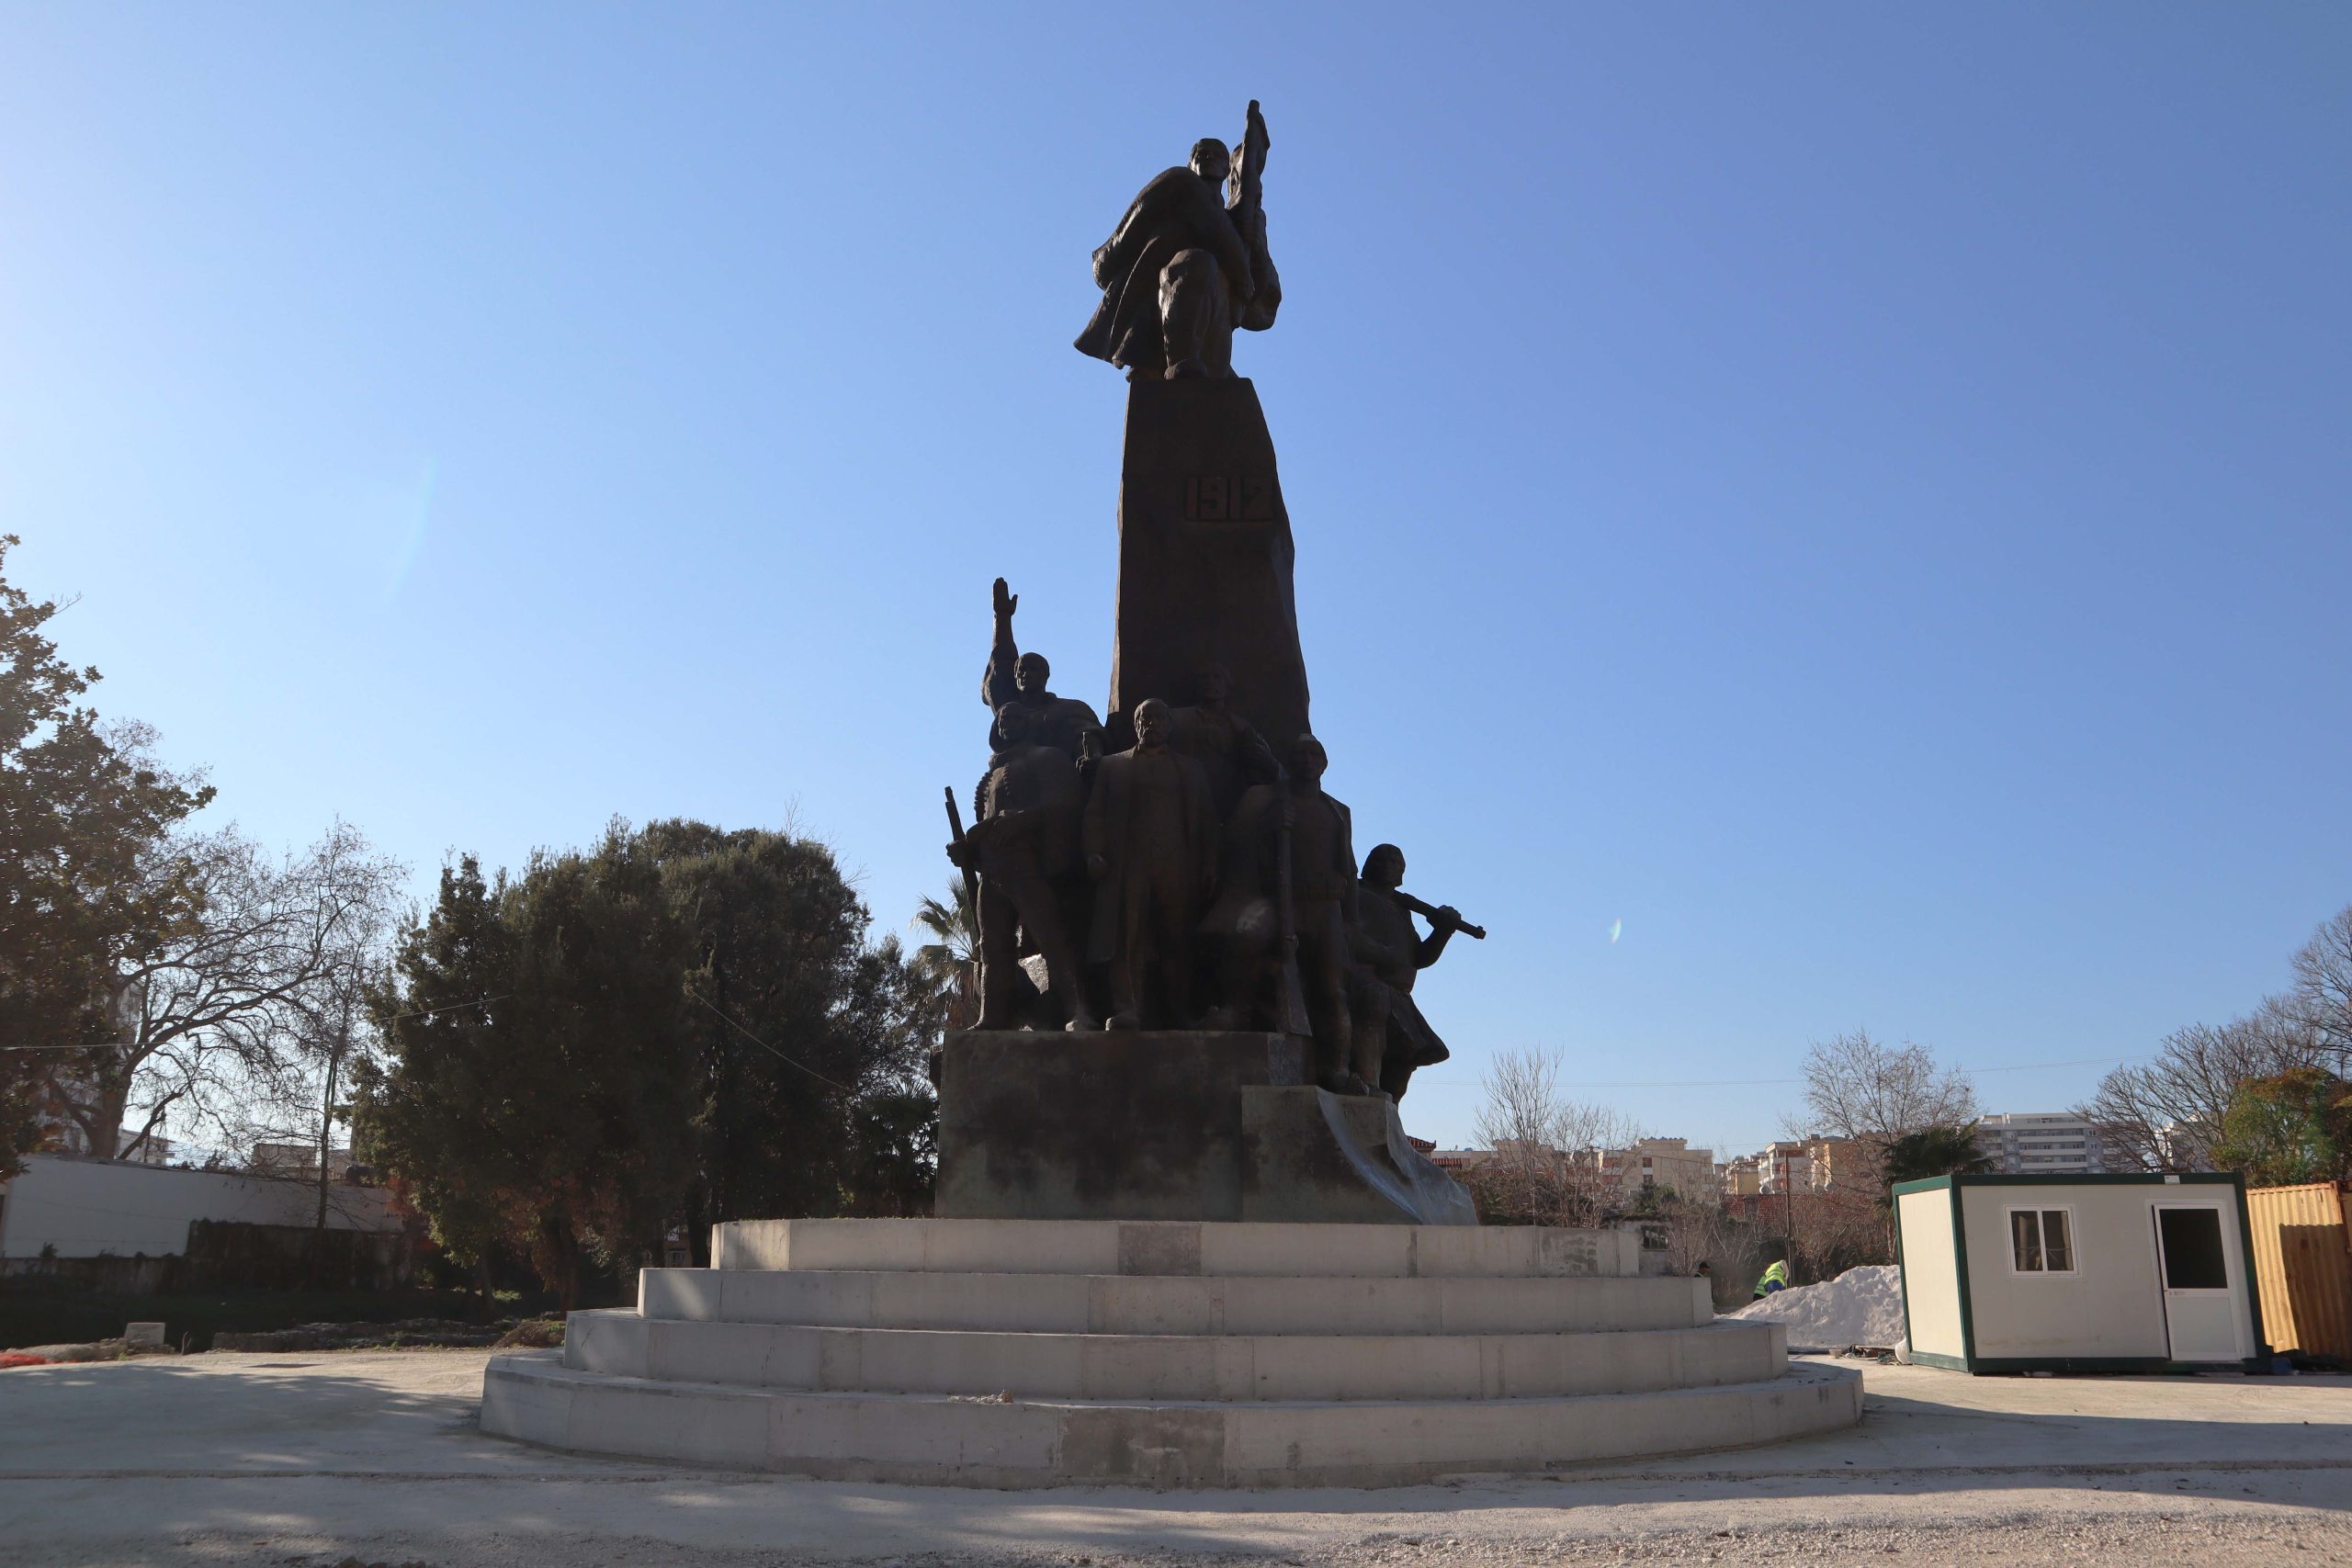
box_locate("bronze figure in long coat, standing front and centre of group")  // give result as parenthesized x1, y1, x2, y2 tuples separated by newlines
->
(1084, 698, 1216, 1030)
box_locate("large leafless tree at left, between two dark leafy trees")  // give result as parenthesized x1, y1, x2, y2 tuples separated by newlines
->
(59, 823, 404, 1155)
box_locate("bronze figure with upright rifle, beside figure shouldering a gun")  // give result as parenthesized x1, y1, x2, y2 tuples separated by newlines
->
(1202, 736, 1371, 1093)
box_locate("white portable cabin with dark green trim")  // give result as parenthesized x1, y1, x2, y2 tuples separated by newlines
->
(1894, 1173, 2269, 1373)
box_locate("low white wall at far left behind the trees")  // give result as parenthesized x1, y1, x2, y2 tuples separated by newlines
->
(0, 1155, 400, 1258)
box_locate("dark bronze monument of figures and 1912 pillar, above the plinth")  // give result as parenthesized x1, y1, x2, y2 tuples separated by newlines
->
(948, 104, 1484, 1098)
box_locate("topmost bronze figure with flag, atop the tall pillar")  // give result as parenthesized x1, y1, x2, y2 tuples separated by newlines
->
(1077, 98, 1282, 381)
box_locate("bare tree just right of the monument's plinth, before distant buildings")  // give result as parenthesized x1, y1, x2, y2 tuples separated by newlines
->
(1465, 1046, 1642, 1224)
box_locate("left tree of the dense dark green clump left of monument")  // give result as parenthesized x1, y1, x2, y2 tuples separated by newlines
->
(357, 828, 692, 1307)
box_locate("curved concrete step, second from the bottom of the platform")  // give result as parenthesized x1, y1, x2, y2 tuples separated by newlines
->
(562, 1312, 1788, 1401)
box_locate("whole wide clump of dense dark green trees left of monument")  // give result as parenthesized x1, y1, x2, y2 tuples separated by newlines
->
(360, 820, 933, 1303)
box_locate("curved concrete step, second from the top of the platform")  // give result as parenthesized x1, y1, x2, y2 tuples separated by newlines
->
(638, 1269, 1714, 1336)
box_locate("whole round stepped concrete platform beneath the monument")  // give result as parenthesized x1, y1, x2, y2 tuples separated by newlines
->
(482, 1220, 1860, 1488)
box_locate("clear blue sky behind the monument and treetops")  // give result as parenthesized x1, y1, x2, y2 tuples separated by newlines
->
(0, 5, 2352, 1147)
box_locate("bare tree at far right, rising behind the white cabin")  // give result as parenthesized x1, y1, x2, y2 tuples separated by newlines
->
(2075, 1001, 2334, 1170)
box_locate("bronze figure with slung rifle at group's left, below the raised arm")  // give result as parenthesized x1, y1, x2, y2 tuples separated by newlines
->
(948, 703, 1096, 1030)
